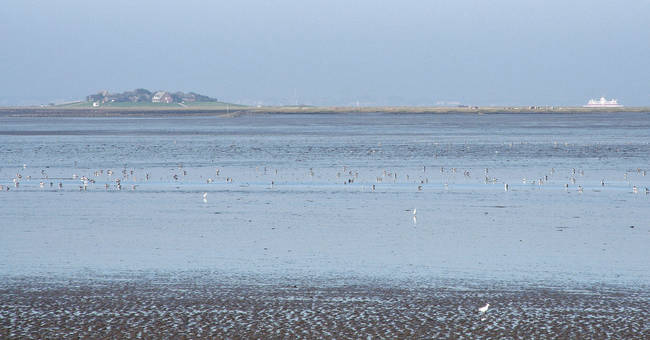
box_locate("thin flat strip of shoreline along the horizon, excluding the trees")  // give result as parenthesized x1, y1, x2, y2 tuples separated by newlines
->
(0, 105, 650, 117)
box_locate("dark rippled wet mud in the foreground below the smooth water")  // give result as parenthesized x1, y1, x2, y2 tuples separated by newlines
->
(0, 277, 650, 339)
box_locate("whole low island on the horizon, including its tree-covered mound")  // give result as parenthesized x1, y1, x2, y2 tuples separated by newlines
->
(0, 88, 650, 117)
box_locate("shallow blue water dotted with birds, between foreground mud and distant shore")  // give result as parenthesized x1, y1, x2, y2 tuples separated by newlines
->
(0, 114, 650, 286)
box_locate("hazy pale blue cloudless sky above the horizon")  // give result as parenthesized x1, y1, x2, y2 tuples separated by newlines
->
(0, 0, 650, 106)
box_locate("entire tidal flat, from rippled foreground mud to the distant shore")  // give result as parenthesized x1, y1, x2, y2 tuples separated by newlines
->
(0, 112, 650, 338)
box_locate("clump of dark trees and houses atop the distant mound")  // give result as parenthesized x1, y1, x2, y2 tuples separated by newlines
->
(86, 89, 219, 107)
